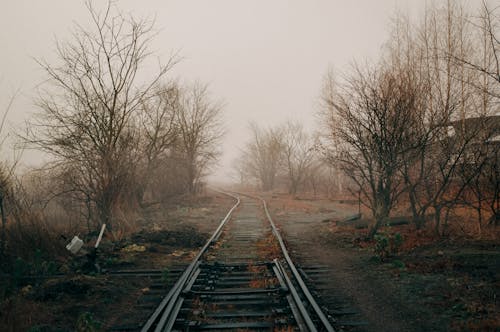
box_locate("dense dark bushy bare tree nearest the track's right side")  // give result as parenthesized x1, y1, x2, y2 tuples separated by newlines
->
(323, 67, 420, 237)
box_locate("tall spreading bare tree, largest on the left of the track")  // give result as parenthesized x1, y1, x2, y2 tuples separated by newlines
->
(27, 1, 173, 231)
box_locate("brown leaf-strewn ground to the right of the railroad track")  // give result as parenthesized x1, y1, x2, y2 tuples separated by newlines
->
(269, 195, 500, 331)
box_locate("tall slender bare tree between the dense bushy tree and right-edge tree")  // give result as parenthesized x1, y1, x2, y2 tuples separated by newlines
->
(419, 2, 480, 234)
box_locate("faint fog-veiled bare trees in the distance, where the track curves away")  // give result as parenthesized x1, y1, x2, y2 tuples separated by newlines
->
(233, 121, 350, 197)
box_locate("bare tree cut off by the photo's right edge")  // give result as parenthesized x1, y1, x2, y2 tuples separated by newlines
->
(446, 1, 500, 232)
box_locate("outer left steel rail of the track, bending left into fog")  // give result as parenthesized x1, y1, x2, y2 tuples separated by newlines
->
(141, 191, 241, 332)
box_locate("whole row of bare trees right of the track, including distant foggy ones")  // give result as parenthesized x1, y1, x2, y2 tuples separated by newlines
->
(237, 2, 500, 236)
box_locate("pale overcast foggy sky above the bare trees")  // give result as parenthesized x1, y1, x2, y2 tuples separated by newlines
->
(0, 0, 432, 178)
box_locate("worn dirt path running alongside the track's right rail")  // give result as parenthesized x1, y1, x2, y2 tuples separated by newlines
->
(271, 197, 446, 332)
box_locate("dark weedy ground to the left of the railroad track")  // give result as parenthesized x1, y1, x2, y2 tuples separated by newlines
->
(0, 194, 234, 332)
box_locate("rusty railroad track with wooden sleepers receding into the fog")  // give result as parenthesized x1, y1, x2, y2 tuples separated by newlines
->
(141, 194, 334, 332)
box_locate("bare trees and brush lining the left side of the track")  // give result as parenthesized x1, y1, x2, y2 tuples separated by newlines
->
(0, 1, 224, 255)
